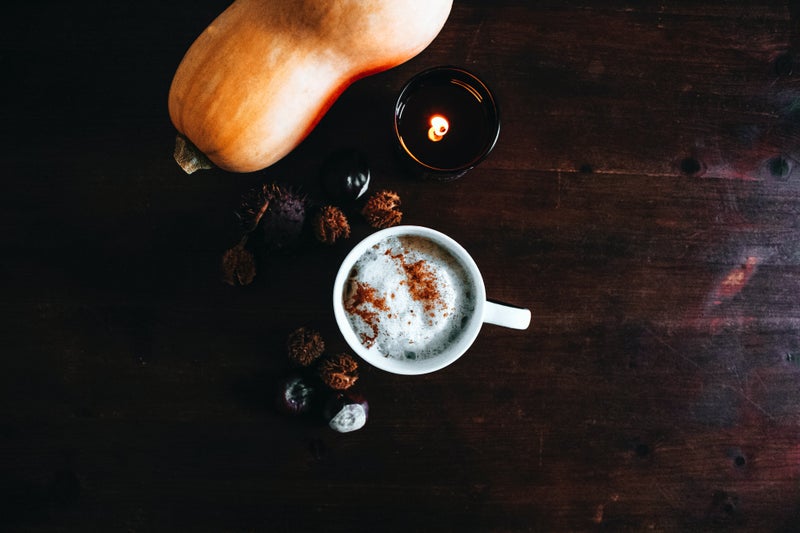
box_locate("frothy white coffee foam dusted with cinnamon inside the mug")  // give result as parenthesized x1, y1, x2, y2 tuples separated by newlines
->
(343, 236, 475, 359)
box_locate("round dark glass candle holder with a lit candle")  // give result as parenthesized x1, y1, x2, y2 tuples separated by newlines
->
(394, 66, 500, 181)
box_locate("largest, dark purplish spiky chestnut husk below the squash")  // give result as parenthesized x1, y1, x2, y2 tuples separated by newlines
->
(237, 183, 307, 249)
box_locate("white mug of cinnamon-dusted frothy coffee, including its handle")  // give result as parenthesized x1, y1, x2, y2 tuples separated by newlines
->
(333, 226, 530, 374)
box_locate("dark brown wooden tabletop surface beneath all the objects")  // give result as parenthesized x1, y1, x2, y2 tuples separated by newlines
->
(0, 0, 800, 532)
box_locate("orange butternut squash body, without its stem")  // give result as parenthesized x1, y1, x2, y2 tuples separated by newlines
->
(168, 0, 452, 172)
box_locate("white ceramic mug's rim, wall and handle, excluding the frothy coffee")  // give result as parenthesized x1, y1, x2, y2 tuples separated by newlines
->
(333, 226, 531, 375)
